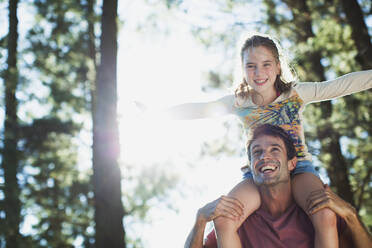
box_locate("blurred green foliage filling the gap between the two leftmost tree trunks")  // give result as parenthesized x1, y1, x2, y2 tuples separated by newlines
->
(0, 1, 94, 247)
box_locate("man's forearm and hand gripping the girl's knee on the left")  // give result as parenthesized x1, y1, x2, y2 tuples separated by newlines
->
(184, 196, 243, 248)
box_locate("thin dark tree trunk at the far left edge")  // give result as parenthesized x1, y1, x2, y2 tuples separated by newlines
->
(2, 0, 21, 248)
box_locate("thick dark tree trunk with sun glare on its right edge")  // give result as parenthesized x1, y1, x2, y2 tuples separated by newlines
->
(93, 0, 125, 248)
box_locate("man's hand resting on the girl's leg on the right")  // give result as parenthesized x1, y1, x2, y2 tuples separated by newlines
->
(307, 184, 356, 218)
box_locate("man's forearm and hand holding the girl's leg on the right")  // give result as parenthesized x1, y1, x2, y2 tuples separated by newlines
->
(308, 185, 372, 248)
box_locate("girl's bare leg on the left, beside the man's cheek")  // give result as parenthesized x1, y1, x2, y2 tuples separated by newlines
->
(214, 179, 261, 248)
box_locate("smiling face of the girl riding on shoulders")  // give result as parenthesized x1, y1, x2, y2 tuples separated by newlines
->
(243, 46, 280, 94)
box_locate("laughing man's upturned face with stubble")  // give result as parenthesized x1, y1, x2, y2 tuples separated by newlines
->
(249, 135, 295, 185)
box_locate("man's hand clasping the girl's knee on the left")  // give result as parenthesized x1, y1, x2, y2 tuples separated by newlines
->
(198, 196, 244, 222)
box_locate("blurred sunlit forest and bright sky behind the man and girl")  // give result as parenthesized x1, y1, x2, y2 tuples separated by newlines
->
(0, 0, 372, 248)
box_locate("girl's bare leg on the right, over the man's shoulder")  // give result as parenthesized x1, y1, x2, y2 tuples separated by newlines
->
(292, 172, 338, 248)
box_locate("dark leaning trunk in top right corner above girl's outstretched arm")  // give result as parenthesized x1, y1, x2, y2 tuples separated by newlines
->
(341, 0, 372, 70)
